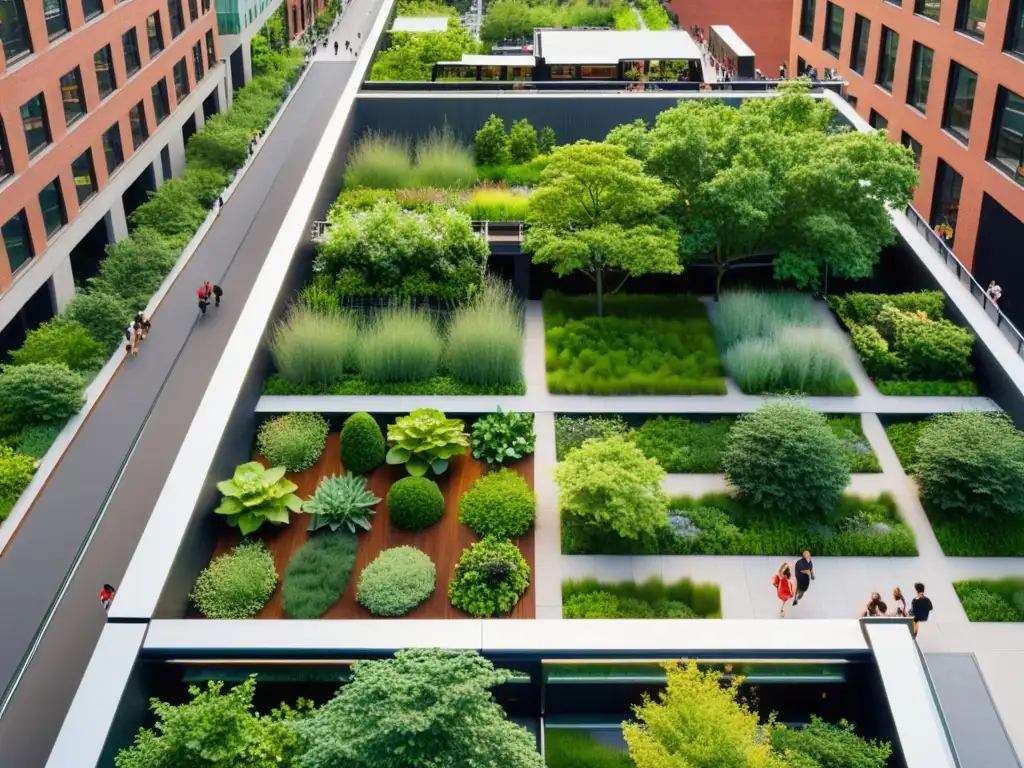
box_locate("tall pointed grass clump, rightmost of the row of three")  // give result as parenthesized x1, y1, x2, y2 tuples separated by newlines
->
(444, 279, 523, 386)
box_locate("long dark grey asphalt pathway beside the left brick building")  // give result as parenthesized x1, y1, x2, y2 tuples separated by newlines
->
(0, 55, 356, 768)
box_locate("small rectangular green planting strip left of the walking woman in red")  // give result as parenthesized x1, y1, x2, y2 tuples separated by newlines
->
(562, 577, 722, 618)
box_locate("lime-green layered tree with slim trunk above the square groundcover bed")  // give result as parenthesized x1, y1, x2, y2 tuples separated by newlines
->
(523, 141, 682, 317)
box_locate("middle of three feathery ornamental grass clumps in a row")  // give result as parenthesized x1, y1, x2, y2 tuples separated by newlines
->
(355, 306, 442, 384)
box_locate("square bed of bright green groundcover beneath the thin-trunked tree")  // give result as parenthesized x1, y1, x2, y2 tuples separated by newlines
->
(544, 292, 725, 394)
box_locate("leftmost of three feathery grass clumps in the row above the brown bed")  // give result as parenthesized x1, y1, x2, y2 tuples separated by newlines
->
(270, 304, 356, 387)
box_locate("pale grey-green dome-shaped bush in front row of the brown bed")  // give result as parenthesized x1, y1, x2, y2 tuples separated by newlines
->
(355, 547, 437, 616)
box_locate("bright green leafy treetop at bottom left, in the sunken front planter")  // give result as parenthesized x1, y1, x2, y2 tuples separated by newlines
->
(114, 675, 311, 768)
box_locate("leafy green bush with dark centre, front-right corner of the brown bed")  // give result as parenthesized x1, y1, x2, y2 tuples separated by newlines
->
(449, 539, 529, 616)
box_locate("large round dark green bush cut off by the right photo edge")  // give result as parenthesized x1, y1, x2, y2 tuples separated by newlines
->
(913, 413, 1024, 518)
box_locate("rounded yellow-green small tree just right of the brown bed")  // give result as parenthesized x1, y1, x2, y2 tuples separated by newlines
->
(555, 436, 669, 539)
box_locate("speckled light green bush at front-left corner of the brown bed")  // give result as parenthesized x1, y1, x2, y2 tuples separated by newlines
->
(189, 541, 278, 618)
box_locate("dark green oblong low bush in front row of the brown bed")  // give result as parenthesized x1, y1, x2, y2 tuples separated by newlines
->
(282, 528, 359, 618)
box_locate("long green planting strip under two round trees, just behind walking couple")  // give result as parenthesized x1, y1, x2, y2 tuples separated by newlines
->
(561, 494, 918, 557)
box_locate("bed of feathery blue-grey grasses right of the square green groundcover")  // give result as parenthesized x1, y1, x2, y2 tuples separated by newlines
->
(716, 291, 857, 395)
